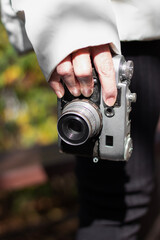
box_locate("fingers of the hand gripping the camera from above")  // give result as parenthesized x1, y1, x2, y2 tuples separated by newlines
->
(49, 44, 117, 106)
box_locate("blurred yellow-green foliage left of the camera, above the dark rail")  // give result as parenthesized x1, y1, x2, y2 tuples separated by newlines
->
(0, 24, 57, 151)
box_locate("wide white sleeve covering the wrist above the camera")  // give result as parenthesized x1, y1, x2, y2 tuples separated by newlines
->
(11, 0, 120, 80)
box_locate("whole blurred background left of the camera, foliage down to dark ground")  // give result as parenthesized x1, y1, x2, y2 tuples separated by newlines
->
(0, 23, 77, 240)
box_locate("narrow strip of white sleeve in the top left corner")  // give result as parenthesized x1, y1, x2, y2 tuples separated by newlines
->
(1, 0, 32, 53)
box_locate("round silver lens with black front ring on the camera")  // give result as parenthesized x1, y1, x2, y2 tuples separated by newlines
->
(57, 100, 101, 145)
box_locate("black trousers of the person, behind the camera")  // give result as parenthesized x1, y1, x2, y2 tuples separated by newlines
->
(76, 41, 160, 240)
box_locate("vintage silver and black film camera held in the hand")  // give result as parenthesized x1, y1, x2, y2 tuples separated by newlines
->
(57, 55, 136, 162)
